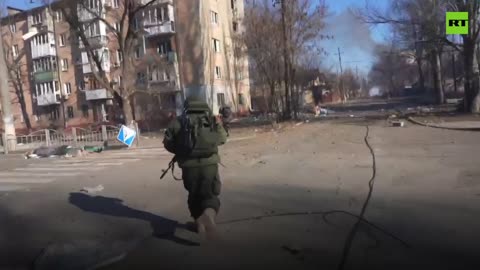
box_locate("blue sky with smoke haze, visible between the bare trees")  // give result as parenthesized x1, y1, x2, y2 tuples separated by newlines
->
(6, 0, 394, 74)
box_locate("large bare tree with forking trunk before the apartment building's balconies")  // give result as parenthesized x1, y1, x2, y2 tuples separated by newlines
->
(56, 0, 164, 123)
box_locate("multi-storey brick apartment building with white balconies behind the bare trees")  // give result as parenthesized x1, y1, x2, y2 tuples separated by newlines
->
(2, 0, 250, 129)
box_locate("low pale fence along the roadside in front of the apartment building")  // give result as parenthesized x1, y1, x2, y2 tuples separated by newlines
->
(0, 125, 138, 153)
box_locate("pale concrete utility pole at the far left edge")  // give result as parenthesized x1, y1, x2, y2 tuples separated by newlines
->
(0, 32, 17, 153)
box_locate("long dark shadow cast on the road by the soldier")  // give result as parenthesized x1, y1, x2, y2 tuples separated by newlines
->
(69, 193, 199, 246)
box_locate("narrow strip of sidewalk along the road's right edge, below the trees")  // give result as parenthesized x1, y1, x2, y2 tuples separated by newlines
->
(408, 115, 480, 130)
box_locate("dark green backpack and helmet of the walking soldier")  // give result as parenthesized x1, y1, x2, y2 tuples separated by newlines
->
(176, 101, 219, 158)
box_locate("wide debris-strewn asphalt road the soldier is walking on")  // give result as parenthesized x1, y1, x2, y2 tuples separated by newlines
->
(0, 99, 480, 269)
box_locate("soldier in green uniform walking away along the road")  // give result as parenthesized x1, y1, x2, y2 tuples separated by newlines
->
(162, 98, 227, 238)
